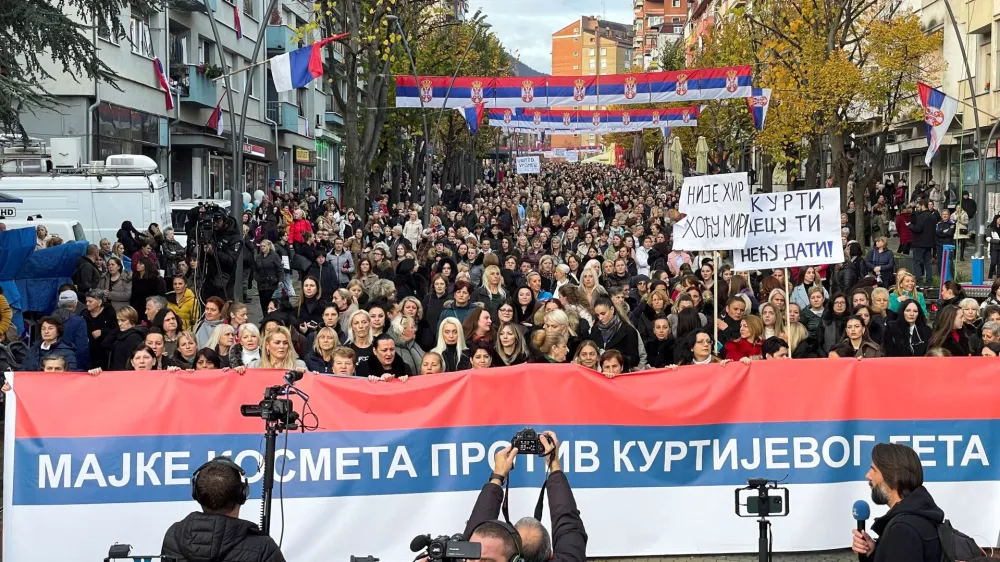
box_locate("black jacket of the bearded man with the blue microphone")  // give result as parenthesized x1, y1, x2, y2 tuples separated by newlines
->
(864, 486, 944, 562)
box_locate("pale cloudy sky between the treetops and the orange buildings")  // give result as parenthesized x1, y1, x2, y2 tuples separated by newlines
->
(469, 0, 633, 74)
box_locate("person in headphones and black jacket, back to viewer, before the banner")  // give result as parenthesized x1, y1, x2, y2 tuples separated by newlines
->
(160, 457, 285, 562)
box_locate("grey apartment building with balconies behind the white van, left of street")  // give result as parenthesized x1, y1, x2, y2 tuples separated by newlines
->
(22, 0, 343, 199)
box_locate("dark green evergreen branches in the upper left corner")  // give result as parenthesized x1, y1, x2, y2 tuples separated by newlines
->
(0, 0, 159, 140)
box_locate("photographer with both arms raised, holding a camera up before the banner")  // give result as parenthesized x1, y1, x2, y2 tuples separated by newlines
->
(465, 431, 587, 562)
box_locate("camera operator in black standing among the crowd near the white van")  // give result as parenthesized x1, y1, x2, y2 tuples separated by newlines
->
(187, 205, 243, 302)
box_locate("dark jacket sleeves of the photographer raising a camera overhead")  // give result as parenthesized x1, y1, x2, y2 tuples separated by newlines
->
(465, 471, 587, 562)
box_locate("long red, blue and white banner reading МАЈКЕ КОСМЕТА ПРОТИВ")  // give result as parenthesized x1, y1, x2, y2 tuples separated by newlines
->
(3, 358, 1000, 562)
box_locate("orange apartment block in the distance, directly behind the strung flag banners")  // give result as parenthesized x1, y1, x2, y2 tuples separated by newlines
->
(551, 16, 635, 148)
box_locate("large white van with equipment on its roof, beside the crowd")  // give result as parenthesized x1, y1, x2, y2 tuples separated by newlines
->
(0, 155, 173, 244)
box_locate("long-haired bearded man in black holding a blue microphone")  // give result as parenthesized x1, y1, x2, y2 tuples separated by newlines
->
(852, 443, 944, 562)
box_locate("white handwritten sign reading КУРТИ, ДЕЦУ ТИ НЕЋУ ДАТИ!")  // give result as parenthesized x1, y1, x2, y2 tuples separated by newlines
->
(733, 189, 844, 271)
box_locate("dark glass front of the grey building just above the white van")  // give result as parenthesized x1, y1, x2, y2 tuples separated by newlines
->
(93, 103, 166, 161)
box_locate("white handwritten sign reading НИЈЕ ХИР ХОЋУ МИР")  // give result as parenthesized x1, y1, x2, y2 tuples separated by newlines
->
(674, 172, 750, 251)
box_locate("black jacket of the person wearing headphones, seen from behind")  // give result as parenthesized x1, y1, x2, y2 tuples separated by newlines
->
(160, 512, 285, 562)
